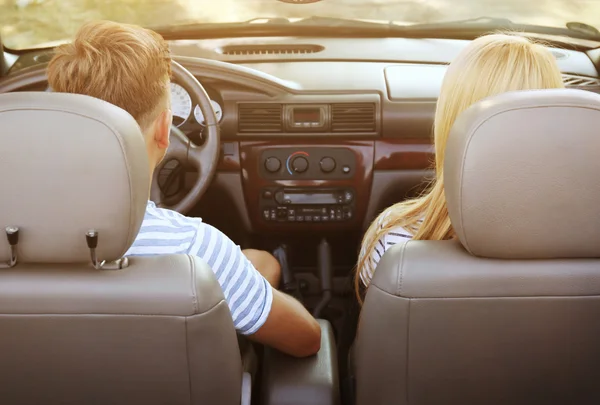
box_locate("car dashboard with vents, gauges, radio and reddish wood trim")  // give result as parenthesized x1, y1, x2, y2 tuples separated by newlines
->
(0, 37, 600, 234)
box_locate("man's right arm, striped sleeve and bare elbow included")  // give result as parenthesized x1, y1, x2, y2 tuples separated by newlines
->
(188, 223, 321, 357)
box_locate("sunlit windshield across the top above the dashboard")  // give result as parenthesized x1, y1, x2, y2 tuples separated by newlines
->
(0, 0, 600, 49)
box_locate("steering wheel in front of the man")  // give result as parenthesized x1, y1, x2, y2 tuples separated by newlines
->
(150, 61, 221, 213)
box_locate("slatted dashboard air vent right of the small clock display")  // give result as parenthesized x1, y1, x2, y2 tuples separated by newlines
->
(331, 103, 375, 132)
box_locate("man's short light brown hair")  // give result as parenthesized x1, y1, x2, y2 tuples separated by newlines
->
(48, 21, 171, 130)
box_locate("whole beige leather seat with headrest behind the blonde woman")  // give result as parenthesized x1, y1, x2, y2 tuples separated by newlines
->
(355, 90, 600, 405)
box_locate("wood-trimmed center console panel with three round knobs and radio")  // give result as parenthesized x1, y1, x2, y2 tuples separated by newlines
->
(240, 140, 373, 231)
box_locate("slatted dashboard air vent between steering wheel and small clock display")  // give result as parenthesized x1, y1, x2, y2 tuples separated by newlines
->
(238, 104, 283, 133)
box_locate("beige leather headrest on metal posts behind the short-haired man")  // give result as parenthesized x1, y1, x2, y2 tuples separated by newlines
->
(0, 92, 150, 266)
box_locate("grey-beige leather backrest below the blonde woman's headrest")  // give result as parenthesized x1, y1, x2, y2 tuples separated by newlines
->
(354, 241, 600, 405)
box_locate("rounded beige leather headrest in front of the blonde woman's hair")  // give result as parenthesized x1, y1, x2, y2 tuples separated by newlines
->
(444, 89, 600, 259)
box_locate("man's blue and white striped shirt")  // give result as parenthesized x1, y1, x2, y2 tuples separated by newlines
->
(126, 201, 273, 335)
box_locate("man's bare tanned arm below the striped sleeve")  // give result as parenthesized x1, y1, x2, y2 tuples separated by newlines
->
(248, 289, 321, 357)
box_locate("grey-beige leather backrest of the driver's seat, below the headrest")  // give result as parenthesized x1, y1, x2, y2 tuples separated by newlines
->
(0, 256, 242, 405)
